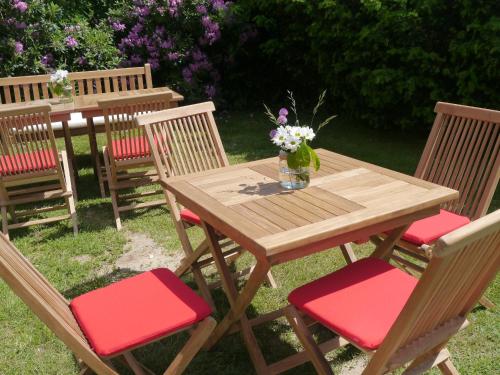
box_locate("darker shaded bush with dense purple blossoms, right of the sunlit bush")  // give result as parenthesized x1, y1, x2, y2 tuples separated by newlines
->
(109, 0, 232, 98)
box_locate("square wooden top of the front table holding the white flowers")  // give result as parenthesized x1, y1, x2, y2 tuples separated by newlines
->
(165, 149, 458, 259)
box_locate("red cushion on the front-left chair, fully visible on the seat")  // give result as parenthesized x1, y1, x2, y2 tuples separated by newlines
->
(70, 268, 211, 357)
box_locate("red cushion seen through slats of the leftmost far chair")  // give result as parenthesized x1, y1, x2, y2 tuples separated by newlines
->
(0, 150, 57, 176)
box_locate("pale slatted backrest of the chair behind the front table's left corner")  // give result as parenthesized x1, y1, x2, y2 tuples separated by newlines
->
(136, 102, 229, 181)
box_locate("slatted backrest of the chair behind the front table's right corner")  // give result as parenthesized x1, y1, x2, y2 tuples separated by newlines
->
(415, 102, 500, 220)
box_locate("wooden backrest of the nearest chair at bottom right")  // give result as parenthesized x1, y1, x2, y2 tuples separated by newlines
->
(365, 210, 500, 374)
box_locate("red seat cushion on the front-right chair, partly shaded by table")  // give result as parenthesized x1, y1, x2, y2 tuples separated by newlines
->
(288, 258, 418, 350)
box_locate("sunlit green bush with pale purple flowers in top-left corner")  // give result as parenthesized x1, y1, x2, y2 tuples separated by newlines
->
(0, 0, 120, 77)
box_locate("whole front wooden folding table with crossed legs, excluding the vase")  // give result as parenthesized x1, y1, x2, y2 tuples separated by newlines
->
(164, 149, 458, 374)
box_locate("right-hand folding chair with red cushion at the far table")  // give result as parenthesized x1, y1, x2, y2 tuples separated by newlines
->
(98, 93, 172, 230)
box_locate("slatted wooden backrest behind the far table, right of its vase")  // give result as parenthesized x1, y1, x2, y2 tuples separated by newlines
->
(68, 64, 153, 96)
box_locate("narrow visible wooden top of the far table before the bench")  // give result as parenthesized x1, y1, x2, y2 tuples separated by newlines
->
(1, 87, 184, 116)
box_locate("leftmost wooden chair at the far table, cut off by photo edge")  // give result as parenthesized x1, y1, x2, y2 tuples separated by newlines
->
(0, 105, 78, 236)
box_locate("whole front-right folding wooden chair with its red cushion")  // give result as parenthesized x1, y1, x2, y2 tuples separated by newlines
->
(278, 210, 500, 375)
